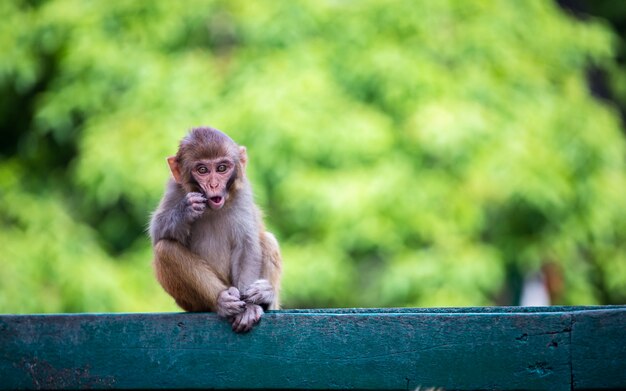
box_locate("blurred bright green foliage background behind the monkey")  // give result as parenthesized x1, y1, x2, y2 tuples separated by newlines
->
(0, 0, 626, 313)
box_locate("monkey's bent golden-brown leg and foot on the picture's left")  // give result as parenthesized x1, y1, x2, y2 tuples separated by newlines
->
(154, 239, 245, 317)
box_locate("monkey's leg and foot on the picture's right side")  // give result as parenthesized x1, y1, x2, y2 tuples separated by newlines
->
(244, 232, 282, 310)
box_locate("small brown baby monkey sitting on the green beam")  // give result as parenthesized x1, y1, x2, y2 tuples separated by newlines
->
(149, 127, 282, 332)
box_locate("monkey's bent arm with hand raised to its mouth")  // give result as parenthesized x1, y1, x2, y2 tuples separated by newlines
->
(150, 181, 206, 246)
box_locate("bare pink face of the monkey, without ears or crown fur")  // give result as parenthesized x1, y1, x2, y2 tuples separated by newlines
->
(192, 158, 235, 210)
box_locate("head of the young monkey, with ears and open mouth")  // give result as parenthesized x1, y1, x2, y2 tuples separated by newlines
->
(167, 127, 247, 210)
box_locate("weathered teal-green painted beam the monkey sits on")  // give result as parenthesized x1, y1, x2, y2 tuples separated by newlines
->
(0, 306, 626, 390)
